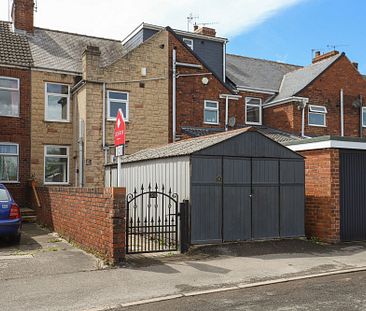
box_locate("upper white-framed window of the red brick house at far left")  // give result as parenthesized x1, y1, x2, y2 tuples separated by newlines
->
(0, 77, 20, 117)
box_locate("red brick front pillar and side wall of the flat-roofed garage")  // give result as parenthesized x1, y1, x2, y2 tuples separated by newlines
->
(300, 149, 340, 242)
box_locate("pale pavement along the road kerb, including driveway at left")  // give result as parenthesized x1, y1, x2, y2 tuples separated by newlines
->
(0, 225, 366, 311)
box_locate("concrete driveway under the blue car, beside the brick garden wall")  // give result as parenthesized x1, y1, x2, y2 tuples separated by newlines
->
(0, 223, 99, 282)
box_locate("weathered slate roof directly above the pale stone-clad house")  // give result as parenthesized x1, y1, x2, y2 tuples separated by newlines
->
(27, 27, 126, 74)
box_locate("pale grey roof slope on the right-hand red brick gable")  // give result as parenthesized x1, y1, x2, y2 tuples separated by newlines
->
(271, 53, 344, 101)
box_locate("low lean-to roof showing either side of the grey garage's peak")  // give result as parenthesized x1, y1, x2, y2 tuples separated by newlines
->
(182, 125, 305, 144)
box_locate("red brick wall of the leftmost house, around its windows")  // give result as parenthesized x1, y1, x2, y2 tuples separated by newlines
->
(0, 67, 31, 206)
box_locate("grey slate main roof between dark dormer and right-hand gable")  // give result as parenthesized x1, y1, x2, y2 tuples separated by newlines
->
(226, 54, 301, 91)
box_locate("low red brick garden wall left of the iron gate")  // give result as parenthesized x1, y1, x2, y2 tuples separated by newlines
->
(33, 187, 125, 263)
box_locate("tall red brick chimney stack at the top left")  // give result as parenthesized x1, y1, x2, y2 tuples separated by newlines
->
(11, 0, 34, 33)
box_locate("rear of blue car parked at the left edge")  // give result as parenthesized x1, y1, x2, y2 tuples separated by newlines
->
(0, 184, 22, 243)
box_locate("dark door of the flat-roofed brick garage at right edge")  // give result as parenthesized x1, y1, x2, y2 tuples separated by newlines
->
(340, 150, 366, 241)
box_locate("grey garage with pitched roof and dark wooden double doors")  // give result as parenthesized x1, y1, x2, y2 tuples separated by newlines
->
(111, 128, 305, 244)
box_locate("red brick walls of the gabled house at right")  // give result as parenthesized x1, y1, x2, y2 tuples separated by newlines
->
(264, 56, 366, 137)
